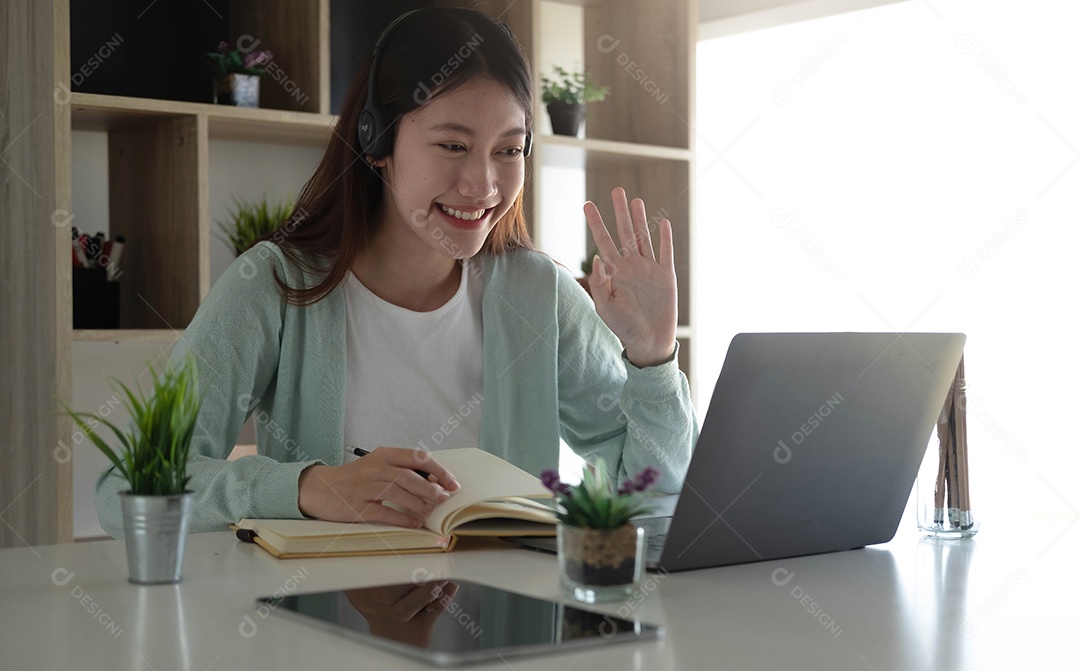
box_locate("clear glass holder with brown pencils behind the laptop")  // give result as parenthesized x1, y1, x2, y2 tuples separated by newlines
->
(916, 359, 978, 539)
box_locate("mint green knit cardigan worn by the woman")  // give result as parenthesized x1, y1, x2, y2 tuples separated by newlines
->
(96, 242, 698, 538)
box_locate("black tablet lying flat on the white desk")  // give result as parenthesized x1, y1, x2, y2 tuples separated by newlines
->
(258, 578, 663, 667)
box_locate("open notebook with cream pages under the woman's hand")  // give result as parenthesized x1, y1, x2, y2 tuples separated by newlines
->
(234, 447, 556, 559)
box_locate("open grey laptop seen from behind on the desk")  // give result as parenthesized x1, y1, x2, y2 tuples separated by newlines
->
(509, 333, 966, 572)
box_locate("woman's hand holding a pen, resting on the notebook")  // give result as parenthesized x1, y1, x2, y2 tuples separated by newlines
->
(298, 447, 460, 528)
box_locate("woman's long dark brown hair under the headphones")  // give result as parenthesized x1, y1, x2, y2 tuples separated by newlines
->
(262, 8, 532, 305)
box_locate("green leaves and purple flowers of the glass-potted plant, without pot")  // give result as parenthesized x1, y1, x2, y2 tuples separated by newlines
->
(540, 459, 660, 529)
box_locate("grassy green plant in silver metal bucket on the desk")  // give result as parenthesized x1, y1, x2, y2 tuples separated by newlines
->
(62, 354, 202, 585)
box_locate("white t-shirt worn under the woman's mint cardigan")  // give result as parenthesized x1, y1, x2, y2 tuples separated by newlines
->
(342, 259, 484, 461)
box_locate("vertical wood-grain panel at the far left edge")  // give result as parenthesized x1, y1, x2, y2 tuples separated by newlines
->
(0, 0, 72, 548)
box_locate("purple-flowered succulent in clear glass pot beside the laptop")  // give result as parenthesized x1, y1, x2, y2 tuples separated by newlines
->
(541, 459, 660, 603)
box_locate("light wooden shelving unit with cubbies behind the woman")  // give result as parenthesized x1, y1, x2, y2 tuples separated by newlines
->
(0, 0, 697, 547)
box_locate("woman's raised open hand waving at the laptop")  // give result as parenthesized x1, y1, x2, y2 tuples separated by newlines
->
(584, 187, 678, 368)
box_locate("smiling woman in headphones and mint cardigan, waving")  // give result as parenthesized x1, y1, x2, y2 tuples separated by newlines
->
(97, 9, 697, 536)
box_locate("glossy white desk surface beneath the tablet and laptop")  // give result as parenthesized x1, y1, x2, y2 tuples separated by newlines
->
(0, 510, 1080, 671)
